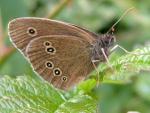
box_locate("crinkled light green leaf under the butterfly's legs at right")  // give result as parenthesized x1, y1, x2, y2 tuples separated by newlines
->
(101, 47, 150, 83)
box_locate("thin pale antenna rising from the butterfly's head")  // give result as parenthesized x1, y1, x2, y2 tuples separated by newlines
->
(107, 7, 135, 34)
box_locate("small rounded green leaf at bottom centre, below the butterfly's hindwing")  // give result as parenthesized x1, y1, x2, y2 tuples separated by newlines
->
(55, 95, 97, 113)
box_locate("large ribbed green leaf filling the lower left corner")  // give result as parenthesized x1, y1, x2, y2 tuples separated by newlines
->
(0, 76, 64, 113)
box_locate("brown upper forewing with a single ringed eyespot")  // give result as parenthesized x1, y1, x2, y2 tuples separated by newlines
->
(9, 17, 95, 55)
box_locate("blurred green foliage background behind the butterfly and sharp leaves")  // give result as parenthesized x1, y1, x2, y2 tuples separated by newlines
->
(0, 0, 150, 113)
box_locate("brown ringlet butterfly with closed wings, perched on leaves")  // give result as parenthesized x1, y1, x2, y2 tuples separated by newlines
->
(8, 8, 134, 90)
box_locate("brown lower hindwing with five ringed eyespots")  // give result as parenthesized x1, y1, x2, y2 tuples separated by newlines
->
(26, 35, 93, 89)
